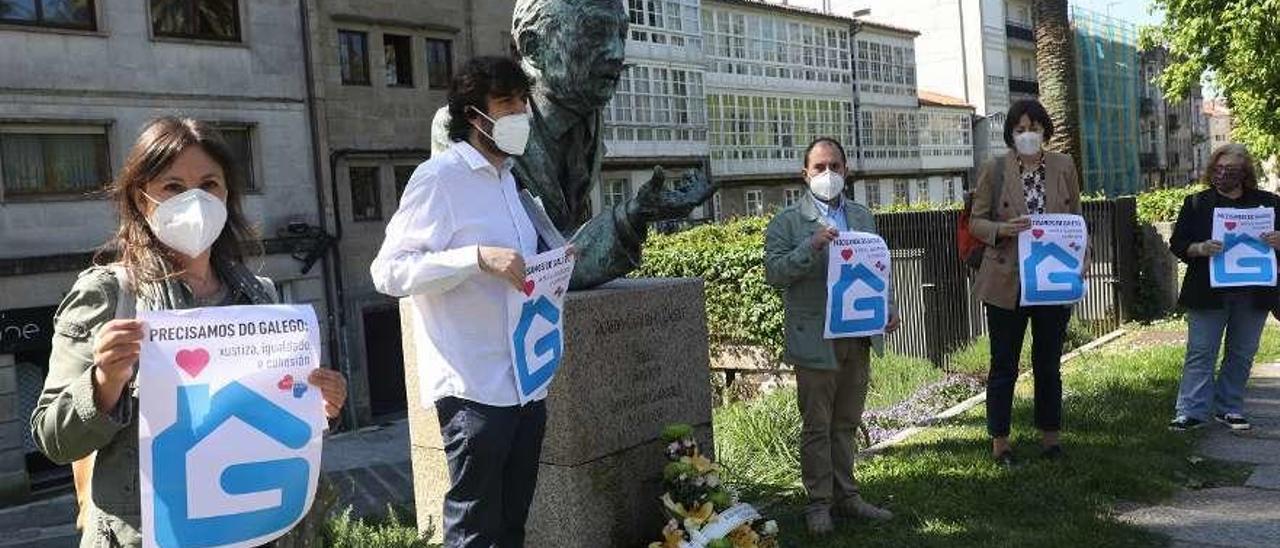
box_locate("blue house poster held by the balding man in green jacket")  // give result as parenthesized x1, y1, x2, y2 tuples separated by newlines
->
(824, 232, 893, 339)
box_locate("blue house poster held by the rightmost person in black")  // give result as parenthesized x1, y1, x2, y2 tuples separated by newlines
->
(1208, 207, 1276, 287)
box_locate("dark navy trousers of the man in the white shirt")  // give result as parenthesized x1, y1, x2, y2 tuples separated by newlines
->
(435, 397, 547, 548)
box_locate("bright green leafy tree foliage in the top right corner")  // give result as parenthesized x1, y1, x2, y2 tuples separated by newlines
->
(1142, 0, 1280, 157)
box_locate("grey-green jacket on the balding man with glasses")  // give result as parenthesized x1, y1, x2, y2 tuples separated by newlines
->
(764, 195, 897, 369)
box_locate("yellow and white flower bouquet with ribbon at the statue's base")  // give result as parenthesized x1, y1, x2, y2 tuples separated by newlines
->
(649, 424, 778, 548)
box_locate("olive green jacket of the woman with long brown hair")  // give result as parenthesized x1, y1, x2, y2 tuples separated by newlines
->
(31, 266, 304, 548)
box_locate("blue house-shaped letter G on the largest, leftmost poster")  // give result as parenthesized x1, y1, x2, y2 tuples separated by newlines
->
(151, 383, 311, 547)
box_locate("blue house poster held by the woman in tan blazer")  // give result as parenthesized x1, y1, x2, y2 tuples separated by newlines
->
(1018, 214, 1089, 306)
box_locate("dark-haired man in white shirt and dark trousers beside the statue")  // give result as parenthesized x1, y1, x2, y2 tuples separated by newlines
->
(370, 58, 548, 548)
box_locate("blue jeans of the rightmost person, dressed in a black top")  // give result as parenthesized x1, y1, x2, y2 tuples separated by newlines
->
(1176, 292, 1267, 421)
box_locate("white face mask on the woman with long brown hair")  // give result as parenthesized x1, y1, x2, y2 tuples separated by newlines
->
(142, 188, 227, 257)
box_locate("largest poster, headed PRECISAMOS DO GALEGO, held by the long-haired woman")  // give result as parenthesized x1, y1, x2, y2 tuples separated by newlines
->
(138, 305, 326, 548)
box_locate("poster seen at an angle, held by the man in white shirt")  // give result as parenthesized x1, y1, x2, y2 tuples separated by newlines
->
(507, 247, 573, 403)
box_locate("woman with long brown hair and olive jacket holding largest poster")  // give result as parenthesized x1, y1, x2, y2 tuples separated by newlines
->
(31, 117, 347, 547)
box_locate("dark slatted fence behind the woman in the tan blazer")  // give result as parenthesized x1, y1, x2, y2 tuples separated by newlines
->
(876, 197, 1138, 367)
